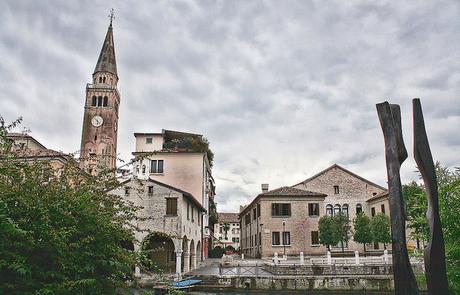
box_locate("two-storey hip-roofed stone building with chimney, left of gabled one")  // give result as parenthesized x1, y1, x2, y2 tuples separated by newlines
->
(239, 185, 326, 257)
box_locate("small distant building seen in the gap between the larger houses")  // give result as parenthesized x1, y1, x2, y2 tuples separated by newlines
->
(214, 213, 240, 250)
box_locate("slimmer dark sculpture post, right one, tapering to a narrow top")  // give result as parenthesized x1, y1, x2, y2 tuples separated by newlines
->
(412, 98, 449, 295)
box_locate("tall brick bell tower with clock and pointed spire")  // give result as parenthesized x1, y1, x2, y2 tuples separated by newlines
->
(80, 10, 120, 175)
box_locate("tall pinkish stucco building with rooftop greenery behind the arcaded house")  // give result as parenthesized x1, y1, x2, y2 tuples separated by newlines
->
(133, 130, 215, 257)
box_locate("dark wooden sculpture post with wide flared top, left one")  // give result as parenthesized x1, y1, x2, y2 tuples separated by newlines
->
(377, 102, 419, 295)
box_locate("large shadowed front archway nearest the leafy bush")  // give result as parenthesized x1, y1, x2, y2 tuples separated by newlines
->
(142, 232, 176, 273)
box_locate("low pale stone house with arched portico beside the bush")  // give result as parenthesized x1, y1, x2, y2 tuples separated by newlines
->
(110, 178, 206, 275)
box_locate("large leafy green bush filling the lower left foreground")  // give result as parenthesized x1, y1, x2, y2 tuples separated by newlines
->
(0, 117, 140, 294)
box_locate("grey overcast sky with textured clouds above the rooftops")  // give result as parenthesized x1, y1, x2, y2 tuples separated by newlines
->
(0, 0, 460, 211)
